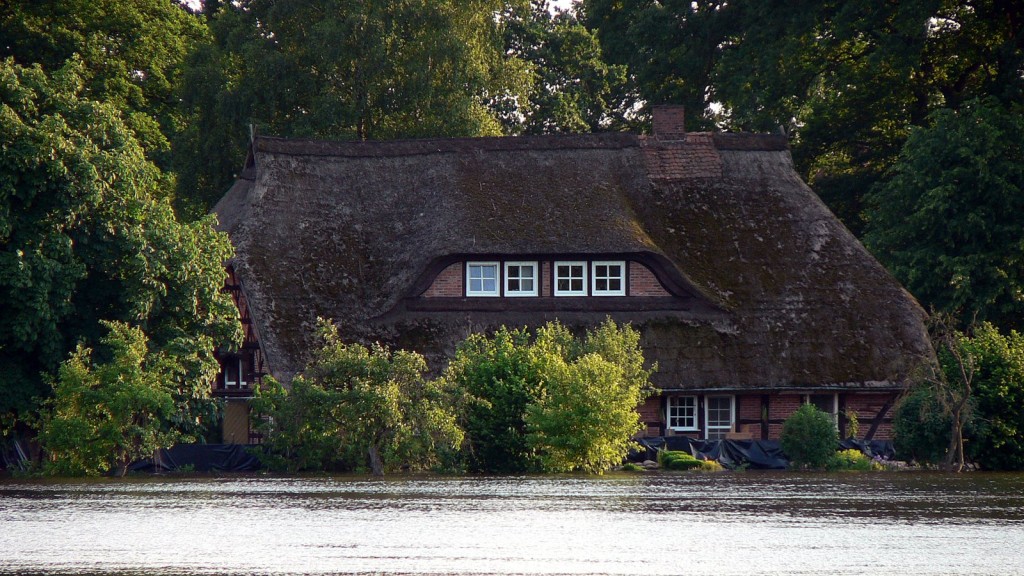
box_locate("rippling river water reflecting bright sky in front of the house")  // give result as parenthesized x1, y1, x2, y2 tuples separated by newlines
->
(0, 471, 1024, 575)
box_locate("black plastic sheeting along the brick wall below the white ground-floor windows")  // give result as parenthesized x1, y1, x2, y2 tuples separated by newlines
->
(633, 436, 896, 470)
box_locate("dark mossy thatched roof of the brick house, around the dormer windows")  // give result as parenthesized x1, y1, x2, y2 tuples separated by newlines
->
(215, 129, 929, 389)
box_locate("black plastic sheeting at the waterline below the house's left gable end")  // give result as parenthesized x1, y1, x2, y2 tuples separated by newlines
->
(128, 444, 262, 474)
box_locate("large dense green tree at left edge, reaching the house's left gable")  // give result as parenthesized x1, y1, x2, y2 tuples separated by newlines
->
(0, 58, 241, 437)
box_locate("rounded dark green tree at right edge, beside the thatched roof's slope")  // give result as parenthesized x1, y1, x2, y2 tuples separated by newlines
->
(864, 98, 1024, 329)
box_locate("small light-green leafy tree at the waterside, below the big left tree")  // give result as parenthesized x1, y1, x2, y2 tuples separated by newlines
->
(38, 322, 181, 476)
